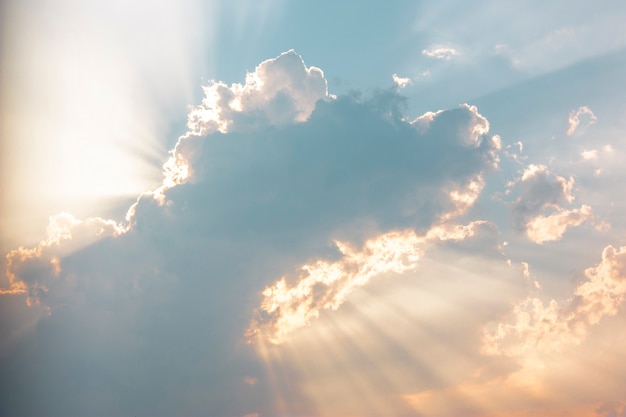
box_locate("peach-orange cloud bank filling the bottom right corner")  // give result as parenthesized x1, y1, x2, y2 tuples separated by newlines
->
(404, 240, 626, 417)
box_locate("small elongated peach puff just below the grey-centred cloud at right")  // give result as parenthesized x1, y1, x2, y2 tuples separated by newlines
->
(526, 205, 593, 244)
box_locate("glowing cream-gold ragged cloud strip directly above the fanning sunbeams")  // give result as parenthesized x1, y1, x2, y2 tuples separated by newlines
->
(247, 222, 483, 344)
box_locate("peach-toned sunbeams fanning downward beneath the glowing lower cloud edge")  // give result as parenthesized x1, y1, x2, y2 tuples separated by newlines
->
(250, 247, 521, 416)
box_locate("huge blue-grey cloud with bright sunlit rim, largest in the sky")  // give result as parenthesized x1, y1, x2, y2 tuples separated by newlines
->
(0, 51, 500, 415)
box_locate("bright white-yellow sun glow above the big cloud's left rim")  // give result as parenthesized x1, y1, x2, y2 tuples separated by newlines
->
(0, 1, 205, 250)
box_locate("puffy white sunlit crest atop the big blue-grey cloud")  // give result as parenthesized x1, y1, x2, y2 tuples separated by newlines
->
(163, 49, 328, 191)
